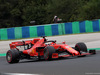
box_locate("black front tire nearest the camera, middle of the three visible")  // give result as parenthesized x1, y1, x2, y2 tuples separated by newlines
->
(44, 46, 55, 60)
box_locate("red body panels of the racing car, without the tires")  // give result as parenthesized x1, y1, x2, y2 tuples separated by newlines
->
(10, 38, 90, 58)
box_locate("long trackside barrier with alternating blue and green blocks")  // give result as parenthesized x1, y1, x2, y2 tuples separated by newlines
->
(0, 19, 100, 40)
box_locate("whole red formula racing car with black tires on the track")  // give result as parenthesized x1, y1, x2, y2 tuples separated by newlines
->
(6, 37, 96, 63)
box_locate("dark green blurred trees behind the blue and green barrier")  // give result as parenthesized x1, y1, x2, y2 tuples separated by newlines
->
(0, 0, 100, 28)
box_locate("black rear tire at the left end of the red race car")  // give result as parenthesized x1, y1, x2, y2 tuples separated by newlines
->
(6, 50, 20, 63)
